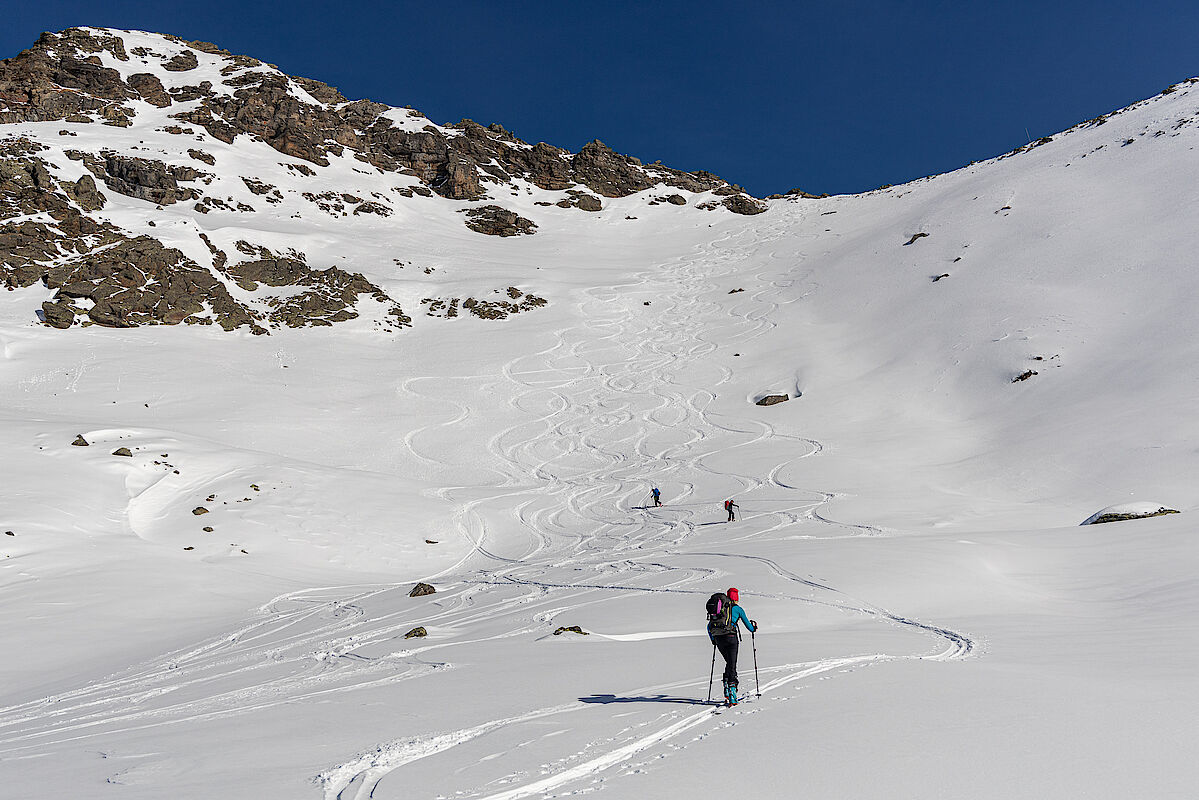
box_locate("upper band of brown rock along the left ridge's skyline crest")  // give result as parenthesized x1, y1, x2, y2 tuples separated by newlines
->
(0, 29, 752, 200)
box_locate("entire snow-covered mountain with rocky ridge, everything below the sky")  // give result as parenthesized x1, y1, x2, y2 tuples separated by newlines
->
(0, 29, 1199, 800)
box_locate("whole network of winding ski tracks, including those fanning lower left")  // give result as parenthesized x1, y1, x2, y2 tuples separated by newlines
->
(0, 211, 974, 800)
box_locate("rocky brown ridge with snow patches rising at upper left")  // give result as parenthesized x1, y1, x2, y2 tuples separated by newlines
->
(0, 28, 766, 333)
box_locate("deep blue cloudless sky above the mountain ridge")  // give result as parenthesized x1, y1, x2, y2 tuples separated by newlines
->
(0, 0, 1199, 196)
